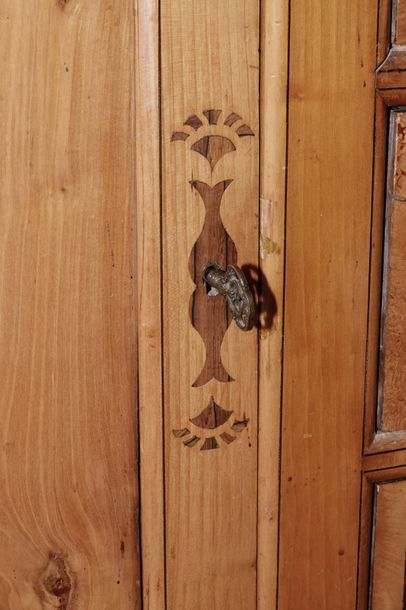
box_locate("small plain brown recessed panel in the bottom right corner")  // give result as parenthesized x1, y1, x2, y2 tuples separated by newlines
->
(371, 480, 406, 610)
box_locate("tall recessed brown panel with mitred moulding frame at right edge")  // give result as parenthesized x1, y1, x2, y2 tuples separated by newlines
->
(365, 102, 406, 453)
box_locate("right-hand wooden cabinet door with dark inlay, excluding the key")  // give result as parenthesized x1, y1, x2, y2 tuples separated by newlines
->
(137, 0, 404, 610)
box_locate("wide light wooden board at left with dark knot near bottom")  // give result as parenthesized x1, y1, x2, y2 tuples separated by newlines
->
(0, 0, 139, 610)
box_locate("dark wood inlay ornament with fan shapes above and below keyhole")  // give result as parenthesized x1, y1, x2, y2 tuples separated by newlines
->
(171, 109, 254, 450)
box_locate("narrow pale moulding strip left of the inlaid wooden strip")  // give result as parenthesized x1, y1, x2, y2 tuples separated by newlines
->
(135, 0, 165, 610)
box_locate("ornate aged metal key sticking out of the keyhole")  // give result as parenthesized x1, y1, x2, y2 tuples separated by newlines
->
(203, 263, 255, 330)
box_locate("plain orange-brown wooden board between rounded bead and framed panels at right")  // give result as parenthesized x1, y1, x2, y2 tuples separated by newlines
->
(279, 0, 377, 610)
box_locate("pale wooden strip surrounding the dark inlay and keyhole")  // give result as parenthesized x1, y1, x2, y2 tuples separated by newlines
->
(161, 0, 259, 610)
